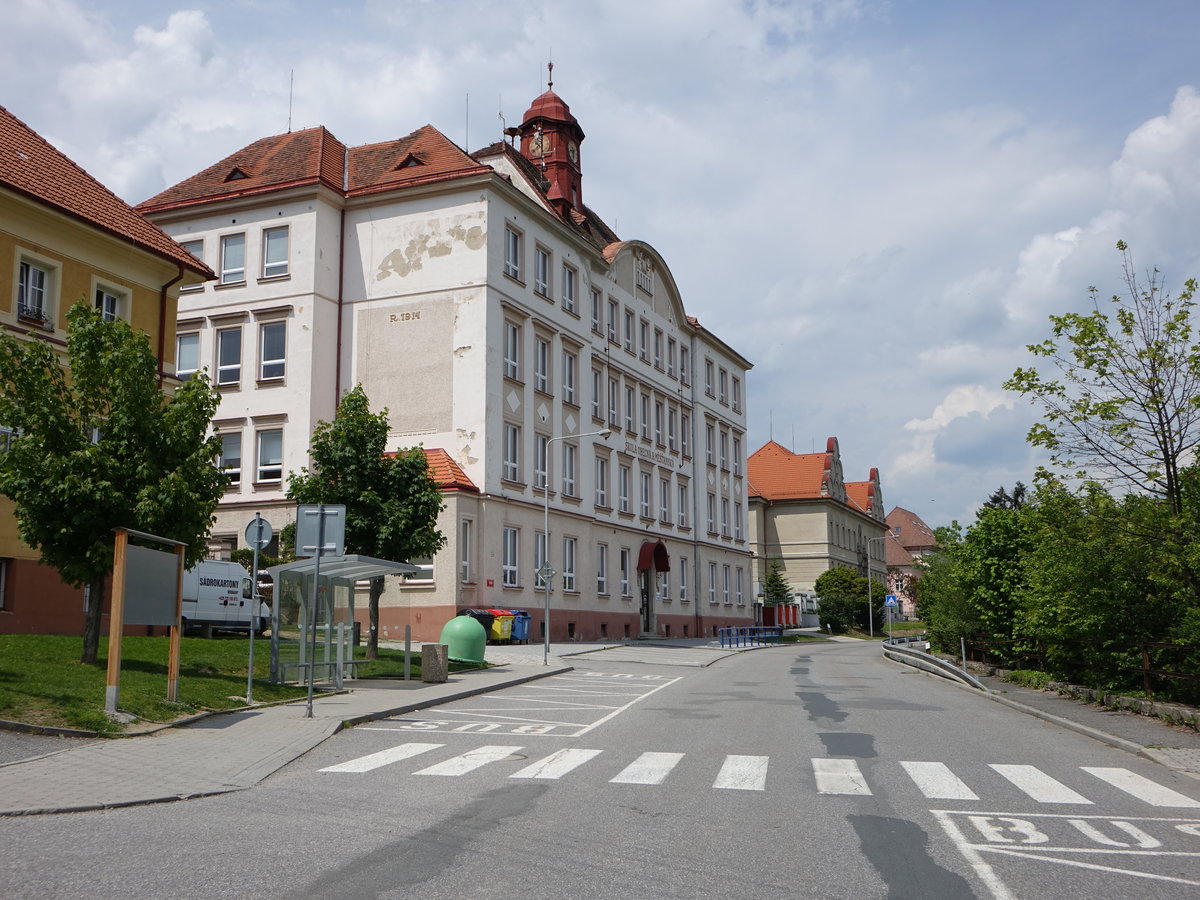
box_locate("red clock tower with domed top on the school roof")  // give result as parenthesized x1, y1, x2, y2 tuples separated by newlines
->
(520, 62, 583, 216)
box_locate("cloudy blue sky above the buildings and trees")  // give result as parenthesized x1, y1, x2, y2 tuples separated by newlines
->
(0, 0, 1200, 524)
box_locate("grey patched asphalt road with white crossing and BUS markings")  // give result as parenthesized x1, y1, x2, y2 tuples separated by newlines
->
(0, 643, 1200, 900)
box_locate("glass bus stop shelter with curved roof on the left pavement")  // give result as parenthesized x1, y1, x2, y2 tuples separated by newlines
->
(266, 554, 420, 686)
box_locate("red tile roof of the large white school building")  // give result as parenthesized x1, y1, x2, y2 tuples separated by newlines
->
(138, 125, 488, 211)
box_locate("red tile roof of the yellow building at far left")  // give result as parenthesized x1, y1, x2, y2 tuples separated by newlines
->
(0, 107, 214, 278)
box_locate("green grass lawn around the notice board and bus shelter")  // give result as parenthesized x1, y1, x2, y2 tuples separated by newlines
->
(0, 635, 473, 734)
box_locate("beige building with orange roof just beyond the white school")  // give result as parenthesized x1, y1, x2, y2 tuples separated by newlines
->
(746, 438, 890, 614)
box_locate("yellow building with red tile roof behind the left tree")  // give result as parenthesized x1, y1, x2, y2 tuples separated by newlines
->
(0, 107, 212, 634)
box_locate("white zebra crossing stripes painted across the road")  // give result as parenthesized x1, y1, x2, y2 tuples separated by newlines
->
(318, 742, 1200, 809)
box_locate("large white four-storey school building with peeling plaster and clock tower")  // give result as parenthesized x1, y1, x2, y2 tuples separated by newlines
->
(139, 77, 752, 640)
